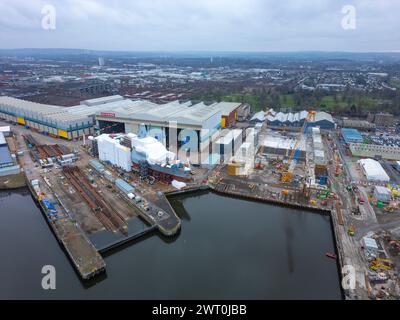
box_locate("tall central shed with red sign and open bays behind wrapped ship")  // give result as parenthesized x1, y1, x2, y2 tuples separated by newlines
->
(96, 100, 224, 150)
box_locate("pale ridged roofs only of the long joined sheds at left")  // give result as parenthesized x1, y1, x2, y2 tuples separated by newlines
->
(0, 95, 241, 126)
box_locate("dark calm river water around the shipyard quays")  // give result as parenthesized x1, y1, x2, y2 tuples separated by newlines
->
(0, 190, 341, 299)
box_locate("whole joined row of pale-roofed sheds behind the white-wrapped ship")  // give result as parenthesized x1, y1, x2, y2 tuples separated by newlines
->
(0, 95, 246, 146)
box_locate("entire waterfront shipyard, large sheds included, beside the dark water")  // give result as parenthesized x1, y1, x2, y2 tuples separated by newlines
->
(0, 85, 400, 299)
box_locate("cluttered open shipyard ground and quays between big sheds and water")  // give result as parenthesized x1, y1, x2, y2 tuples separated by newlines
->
(1, 94, 400, 299)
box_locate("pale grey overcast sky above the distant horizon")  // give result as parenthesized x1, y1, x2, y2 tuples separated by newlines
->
(0, 0, 400, 51)
